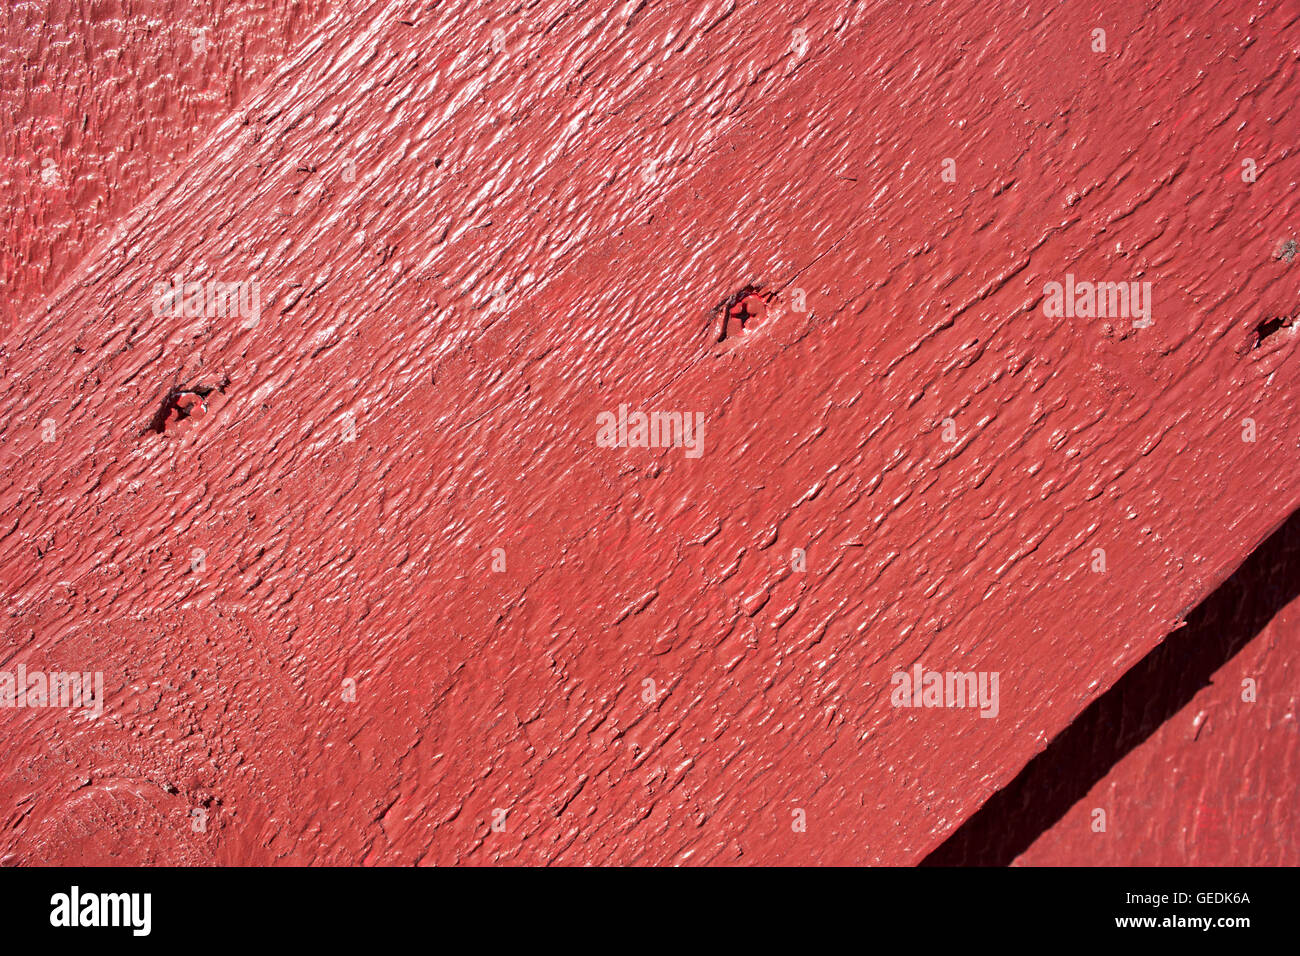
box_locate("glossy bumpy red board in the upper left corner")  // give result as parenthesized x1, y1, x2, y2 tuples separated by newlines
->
(0, 0, 328, 334)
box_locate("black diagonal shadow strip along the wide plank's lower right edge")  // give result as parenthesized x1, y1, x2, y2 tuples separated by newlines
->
(920, 511, 1300, 866)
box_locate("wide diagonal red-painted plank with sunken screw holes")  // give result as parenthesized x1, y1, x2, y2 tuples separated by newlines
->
(0, 1, 1300, 864)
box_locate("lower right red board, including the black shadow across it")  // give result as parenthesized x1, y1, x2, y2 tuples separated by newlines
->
(926, 512, 1300, 866)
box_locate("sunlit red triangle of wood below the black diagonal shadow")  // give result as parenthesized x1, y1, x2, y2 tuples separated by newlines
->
(1017, 582, 1300, 866)
